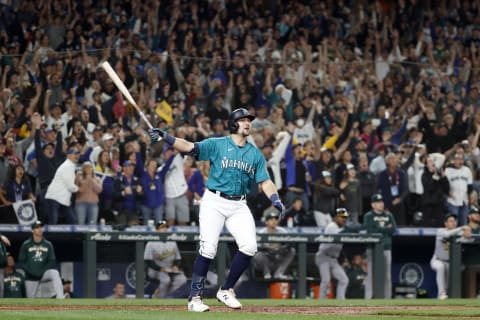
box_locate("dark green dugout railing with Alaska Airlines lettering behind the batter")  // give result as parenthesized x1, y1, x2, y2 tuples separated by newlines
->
(83, 228, 384, 299)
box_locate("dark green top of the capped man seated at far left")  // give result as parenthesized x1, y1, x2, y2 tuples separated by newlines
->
(18, 237, 55, 280)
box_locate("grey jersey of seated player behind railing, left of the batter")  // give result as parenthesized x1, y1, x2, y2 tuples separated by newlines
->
(143, 241, 182, 268)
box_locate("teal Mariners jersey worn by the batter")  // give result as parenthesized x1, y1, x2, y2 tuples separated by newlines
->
(197, 136, 270, 195)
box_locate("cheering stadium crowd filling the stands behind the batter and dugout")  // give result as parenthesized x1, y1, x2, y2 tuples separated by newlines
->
(0, 0, 480, 227)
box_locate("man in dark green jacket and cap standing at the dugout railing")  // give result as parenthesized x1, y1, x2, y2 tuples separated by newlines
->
(363, 193, 397, 299)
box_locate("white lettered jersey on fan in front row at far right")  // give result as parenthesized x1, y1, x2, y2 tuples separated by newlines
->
(445, 166, 473, 206)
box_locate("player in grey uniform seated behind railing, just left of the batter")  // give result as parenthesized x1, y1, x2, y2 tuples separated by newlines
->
(143, 220, 187, 298)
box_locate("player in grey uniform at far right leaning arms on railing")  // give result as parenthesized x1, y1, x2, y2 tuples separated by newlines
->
(430, 213, 471, 300)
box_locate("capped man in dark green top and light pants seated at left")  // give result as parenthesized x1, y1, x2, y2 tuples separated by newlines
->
(18, 221, 64, 299)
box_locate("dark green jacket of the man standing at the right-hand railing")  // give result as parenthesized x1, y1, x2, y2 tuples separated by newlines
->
(363, 210, 397, 250)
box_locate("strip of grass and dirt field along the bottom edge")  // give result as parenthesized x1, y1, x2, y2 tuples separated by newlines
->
(0, 299, 480, 320)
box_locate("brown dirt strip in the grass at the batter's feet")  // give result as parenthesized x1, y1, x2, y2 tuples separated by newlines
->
(0, 305, 461, 318)
